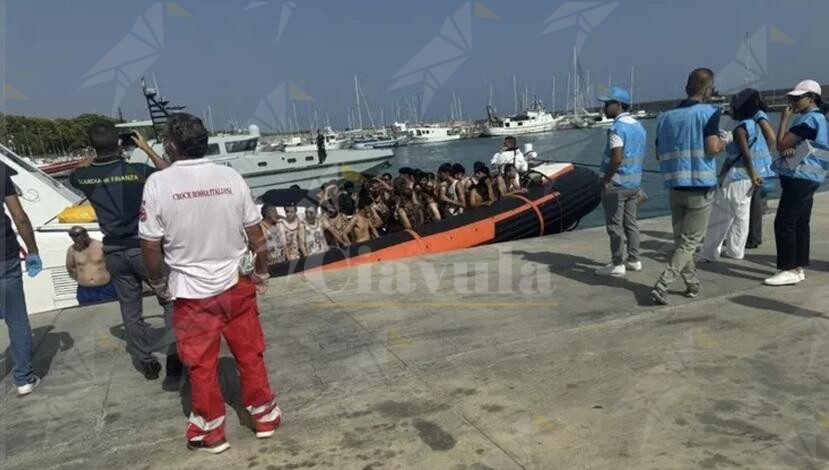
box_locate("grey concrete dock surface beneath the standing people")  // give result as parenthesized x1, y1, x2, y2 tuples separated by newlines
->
(0, 193, 829, 470)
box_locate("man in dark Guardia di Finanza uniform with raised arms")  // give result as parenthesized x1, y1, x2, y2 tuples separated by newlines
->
(69, 121, 181, 385)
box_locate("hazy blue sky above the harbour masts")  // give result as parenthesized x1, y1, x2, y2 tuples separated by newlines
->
(0, 0, 829, 127)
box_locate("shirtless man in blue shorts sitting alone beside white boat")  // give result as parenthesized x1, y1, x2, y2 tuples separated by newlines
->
(66, 226, 118, 305)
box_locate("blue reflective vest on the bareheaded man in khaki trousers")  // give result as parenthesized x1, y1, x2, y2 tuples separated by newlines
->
(656, 103, 718, 189)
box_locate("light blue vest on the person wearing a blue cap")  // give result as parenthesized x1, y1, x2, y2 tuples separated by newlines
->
(601, 114, 648, 189)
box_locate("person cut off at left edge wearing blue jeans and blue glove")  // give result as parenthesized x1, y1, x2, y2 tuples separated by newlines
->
(0, 163, 43, 395)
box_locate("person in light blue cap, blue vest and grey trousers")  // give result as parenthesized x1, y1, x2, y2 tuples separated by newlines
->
(596, 87, 647, 277)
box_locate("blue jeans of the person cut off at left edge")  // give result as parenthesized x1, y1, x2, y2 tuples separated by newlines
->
(0, 258, 34, 386)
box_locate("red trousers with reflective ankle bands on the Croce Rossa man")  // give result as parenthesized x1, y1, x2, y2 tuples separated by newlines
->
(173, 277, 279, 443)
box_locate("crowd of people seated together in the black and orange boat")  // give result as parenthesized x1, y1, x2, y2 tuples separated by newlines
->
(262, 162, 525, 264)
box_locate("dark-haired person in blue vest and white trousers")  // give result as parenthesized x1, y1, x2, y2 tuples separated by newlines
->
(698, 88, 774, 262)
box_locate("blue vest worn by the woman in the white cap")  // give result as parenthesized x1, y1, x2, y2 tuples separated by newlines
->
(774, 109, 829, 183)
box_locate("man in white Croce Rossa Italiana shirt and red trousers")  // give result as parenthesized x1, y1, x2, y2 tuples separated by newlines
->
(139, 114, 282, 454)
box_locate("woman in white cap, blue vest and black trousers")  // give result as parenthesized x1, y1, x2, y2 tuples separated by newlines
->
(765, 80, 829, 286)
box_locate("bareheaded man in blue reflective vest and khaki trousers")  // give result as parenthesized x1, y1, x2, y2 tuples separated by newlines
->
(651, 68, 725, 305)
